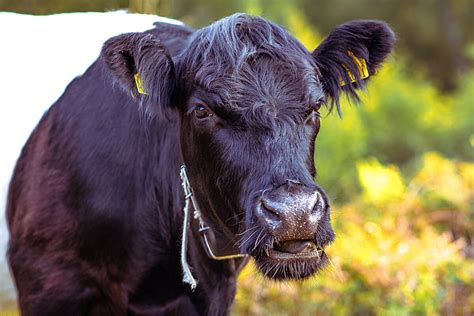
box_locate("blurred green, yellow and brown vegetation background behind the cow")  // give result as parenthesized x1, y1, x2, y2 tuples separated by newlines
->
(0, 0, 474, 315)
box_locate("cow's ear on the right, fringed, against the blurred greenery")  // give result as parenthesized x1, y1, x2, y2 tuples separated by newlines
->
(313, 20, 395, 110)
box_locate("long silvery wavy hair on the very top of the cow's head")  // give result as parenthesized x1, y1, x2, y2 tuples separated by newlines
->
(181, 13, 318, 82)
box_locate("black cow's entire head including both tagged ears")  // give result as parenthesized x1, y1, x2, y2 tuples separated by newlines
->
(103, 14, 394, 279)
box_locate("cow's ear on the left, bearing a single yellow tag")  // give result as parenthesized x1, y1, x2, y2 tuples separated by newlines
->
(101, 33, 175, 114)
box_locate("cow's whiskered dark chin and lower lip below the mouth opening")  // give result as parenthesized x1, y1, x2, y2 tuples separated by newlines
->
(250, 246, 329, 281)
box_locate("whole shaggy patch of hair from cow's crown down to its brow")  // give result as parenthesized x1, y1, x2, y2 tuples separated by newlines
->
(178, 13, 319, 125)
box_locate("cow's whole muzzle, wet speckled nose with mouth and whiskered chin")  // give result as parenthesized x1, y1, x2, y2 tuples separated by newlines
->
(247, 180, 334, 279)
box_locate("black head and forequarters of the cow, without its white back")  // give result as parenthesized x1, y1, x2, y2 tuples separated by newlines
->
(7, 14, 394, 315)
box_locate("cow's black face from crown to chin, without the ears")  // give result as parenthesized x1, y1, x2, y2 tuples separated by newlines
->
(179, 16, 334, 279)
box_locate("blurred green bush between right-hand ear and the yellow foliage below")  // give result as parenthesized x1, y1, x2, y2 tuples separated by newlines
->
(315, 62, 474, 201)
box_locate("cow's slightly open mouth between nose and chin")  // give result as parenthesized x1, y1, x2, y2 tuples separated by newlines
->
(268, 240, 324, 260)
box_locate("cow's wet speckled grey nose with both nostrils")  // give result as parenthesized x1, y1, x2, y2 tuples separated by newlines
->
(257, 181, 325, 240)
